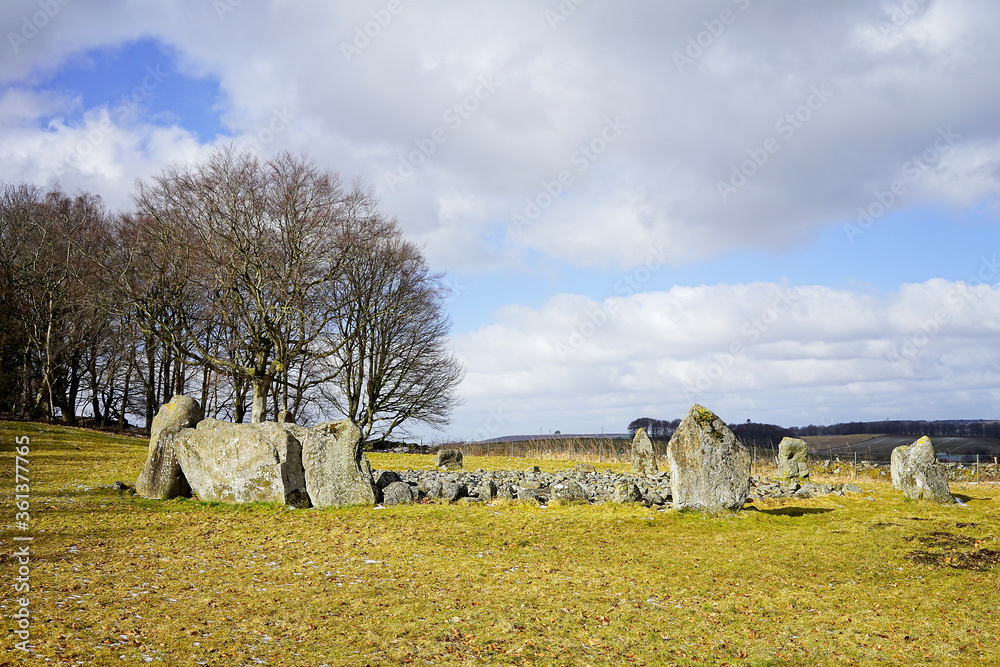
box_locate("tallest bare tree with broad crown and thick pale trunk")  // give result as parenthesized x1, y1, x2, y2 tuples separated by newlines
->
(129, 148, 367, 422)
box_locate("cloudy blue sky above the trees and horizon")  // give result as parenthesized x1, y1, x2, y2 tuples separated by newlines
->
(0, 0, 1000, 442)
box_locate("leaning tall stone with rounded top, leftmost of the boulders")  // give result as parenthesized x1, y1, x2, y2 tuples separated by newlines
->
(135, 394, 204, 500)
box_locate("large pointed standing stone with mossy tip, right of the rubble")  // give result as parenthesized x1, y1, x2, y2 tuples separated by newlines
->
(667, 404, 750, 512)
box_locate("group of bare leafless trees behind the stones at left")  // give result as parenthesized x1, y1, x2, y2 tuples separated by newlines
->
(0, 147, 463, 439)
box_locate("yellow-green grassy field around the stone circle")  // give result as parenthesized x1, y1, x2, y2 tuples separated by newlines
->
(0, 423, 1000, 667)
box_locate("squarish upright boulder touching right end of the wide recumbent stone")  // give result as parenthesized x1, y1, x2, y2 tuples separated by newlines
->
(292, 419, 377, 507)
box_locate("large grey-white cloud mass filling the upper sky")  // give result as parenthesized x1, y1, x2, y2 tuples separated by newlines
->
(0, 0, 1000, 271)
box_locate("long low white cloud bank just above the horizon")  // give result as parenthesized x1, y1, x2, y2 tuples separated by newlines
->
(452, 280, 1000, 438)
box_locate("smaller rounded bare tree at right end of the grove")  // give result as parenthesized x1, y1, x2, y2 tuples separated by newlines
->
(327, 217, 463, 439)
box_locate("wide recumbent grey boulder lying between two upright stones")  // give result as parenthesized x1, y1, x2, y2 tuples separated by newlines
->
(175, 419, 309, 507)
